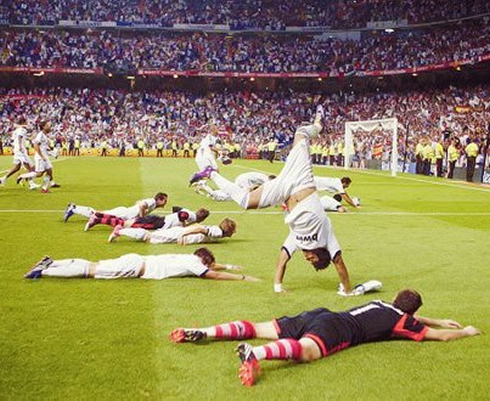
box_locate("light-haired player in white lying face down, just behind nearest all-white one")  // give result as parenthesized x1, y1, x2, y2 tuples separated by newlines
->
(109, 219, 236, 245)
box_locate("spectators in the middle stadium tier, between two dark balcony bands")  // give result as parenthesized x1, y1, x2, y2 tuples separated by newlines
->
(0, 18, 490, 74)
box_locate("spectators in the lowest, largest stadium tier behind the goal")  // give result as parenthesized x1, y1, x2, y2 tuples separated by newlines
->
(0, 86, 490, 173)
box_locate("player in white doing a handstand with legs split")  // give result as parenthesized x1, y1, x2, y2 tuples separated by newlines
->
(189, 106, 352, 295)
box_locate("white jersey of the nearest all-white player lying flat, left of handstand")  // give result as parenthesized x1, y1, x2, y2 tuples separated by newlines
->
(141, 255, 208, 280)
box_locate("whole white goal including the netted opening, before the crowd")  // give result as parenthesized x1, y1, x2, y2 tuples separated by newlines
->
(344, 118, 398, 176)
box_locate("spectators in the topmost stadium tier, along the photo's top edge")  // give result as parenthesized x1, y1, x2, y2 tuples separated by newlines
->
(0, 0, 490, 30)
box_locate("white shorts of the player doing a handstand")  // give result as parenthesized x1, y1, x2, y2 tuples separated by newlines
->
(259, 139, 315, 208)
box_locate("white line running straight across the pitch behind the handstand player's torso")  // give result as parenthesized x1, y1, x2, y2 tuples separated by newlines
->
(0, 209, 490, 217)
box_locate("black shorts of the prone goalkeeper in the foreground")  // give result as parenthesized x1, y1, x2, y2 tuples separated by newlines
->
(274, 308, 350, 357)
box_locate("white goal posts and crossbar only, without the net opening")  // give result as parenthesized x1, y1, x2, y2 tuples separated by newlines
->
(344, 118, 398, 176)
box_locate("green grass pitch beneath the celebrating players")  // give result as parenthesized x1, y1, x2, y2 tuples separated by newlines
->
(0, 157, 490, 400)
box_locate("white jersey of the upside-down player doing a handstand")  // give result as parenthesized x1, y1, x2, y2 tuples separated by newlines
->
(283, 193, 340, 259)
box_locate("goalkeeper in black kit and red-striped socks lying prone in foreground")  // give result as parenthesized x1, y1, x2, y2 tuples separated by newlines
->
(170, 290, 480, 386)
